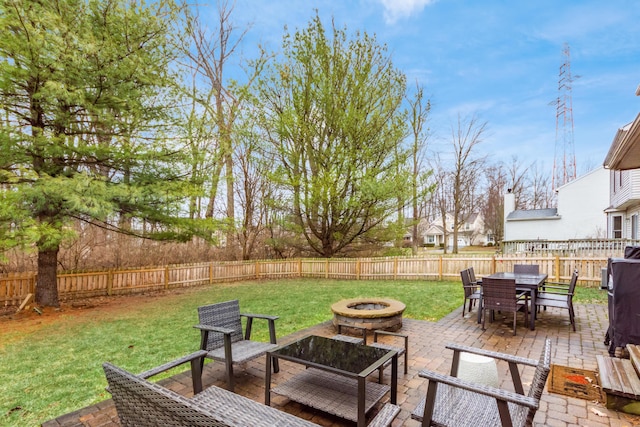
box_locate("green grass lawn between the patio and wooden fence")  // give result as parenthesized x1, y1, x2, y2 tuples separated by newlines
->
(0, 279, 606, 426)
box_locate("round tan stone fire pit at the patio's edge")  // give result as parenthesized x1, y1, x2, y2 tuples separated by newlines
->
(331, 298, 406, 334)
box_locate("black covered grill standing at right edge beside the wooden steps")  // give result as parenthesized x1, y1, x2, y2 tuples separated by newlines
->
(608, 260, 640, 356)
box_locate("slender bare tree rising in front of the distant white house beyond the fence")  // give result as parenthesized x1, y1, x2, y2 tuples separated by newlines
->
(451, 115, 487, 253)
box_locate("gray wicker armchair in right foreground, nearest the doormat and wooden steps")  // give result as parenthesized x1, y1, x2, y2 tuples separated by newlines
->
(411, 339, 551, 427)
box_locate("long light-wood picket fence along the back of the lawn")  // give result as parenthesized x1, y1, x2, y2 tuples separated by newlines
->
(0, 255, 607, 306)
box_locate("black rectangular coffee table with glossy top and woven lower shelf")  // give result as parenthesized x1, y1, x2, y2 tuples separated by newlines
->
(264, 335, 398, 427)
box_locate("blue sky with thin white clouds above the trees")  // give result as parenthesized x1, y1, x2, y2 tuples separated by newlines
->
(221, 0, 640, 175)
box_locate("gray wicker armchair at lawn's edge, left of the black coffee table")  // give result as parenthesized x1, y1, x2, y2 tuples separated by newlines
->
(194, 300, 279, 391)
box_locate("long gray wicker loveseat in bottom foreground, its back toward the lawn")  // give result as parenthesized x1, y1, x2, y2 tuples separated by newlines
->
(102, 363, 400, 427)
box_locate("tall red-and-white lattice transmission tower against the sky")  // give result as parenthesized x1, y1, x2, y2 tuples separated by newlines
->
(551, 43, 576, 191)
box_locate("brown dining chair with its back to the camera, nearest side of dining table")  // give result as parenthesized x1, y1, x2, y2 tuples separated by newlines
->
(482, 277, 529, 335)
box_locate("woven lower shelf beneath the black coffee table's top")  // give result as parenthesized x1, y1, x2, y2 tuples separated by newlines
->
(271, 368, 391, 422)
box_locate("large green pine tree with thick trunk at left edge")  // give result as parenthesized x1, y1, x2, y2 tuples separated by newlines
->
(0, 0, 193, 306)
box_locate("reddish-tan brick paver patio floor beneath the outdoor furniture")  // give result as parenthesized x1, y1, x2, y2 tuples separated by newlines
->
(43, 305, 640, 427)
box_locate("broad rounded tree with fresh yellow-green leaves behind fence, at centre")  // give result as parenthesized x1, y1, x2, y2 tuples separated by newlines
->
(256, 13, 409, 257)
